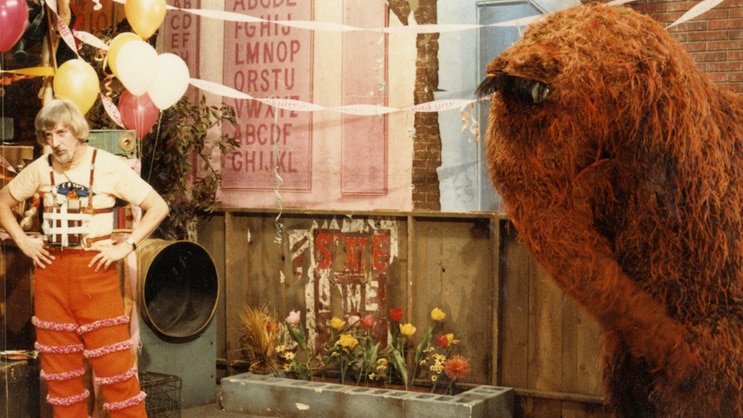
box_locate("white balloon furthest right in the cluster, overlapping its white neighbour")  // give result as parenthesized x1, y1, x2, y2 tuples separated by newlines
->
(147, 52, 191, 110)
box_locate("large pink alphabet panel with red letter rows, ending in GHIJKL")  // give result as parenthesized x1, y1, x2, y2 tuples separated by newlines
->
(222, 0, 313, 191)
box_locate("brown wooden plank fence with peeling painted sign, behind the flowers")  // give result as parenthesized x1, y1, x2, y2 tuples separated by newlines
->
(199, 210, 608, 417)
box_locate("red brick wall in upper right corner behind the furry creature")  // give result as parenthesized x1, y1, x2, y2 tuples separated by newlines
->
(633, 0, 743, 93)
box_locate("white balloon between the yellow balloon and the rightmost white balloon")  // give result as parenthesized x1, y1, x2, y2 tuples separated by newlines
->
(116, 41, 157, 96)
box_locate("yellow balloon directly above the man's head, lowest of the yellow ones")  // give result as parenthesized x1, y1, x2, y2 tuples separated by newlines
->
(52, 58, 100, 114)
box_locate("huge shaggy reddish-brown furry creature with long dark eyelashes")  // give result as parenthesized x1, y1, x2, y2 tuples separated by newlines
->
(478, 5, 743, 418)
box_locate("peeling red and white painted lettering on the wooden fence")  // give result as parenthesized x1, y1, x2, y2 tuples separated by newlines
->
(289, 220, 397, 354)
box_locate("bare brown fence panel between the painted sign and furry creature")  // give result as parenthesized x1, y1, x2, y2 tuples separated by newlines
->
(412, 219, 493, 383)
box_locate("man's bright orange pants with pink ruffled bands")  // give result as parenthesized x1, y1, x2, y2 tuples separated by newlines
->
(33, 249, 147, 418)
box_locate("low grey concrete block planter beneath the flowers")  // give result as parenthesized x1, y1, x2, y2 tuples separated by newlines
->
(220, 373, 513, 418)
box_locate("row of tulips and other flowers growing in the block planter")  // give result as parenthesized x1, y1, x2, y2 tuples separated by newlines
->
(241, 307, 470, 393)
